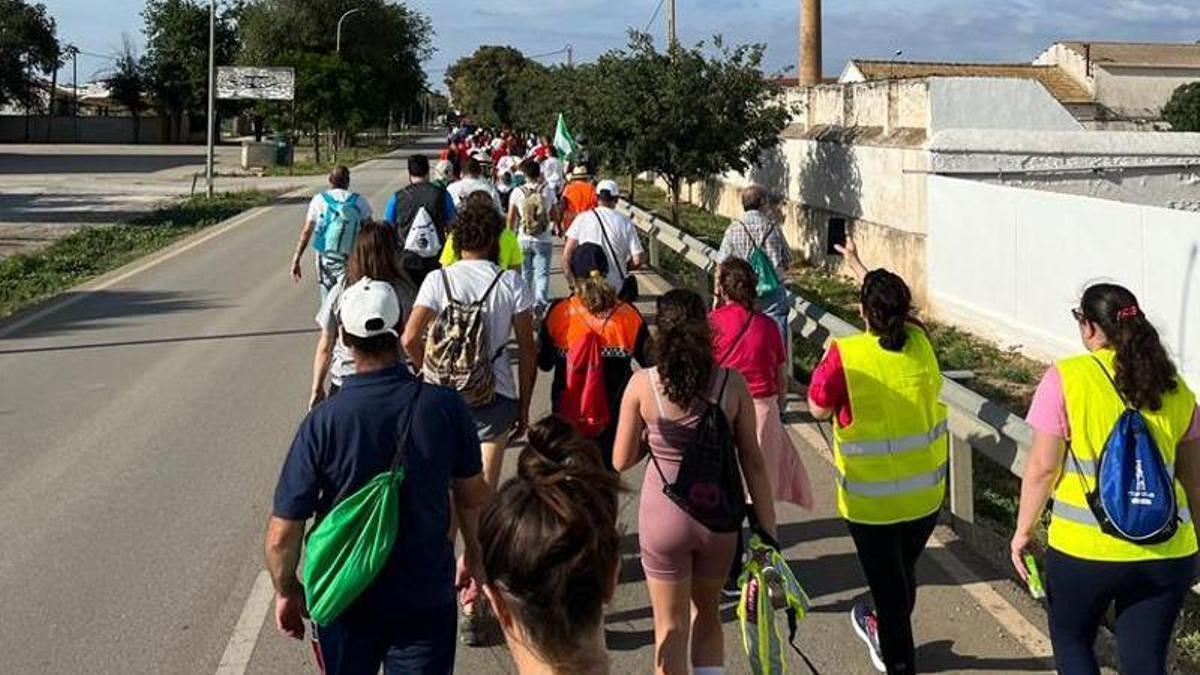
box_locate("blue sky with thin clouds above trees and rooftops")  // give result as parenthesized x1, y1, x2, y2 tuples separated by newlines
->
(41, 0, 1200, 88)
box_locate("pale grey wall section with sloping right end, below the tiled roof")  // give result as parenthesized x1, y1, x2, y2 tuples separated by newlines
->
(929, 77, 1082, 133)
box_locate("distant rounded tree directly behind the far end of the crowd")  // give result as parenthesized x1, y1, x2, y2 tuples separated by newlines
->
(445, 46, 545, 126)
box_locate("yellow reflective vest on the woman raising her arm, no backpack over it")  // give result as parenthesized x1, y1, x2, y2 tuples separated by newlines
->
(834, 327, 949, 525)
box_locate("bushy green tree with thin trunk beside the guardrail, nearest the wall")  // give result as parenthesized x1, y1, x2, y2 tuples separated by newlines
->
(592, 32, 788, 222)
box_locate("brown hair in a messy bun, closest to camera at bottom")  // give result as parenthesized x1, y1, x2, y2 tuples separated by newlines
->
(479, 417, 622, 673)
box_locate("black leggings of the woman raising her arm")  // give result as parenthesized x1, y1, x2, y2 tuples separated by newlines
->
(846, 513, 937, 675)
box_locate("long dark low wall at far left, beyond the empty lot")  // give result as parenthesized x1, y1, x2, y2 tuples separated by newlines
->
(0, 115, 166, 144)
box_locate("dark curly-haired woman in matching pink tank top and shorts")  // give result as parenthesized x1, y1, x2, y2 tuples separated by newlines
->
(613, 291, 775, 675)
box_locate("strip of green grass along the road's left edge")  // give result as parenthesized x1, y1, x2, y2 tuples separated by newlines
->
(0, 190, 276, 317)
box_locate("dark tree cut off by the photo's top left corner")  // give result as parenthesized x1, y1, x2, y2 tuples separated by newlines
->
(0, 0, 60, 109)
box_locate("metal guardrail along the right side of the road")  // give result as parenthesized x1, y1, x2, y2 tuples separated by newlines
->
(619, 199, 1033, 535)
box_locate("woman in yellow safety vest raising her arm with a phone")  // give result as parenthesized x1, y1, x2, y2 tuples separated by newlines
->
(809, 241, 949, 674)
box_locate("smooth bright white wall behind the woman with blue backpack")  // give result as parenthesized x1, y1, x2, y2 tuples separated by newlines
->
(925, 175, 1200, 389)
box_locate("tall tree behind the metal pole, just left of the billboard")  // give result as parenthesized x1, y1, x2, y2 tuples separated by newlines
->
(142, 0, 239, 142)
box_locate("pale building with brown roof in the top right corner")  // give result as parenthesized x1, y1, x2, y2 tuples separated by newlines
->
(1033, 41, 1200, 127)
